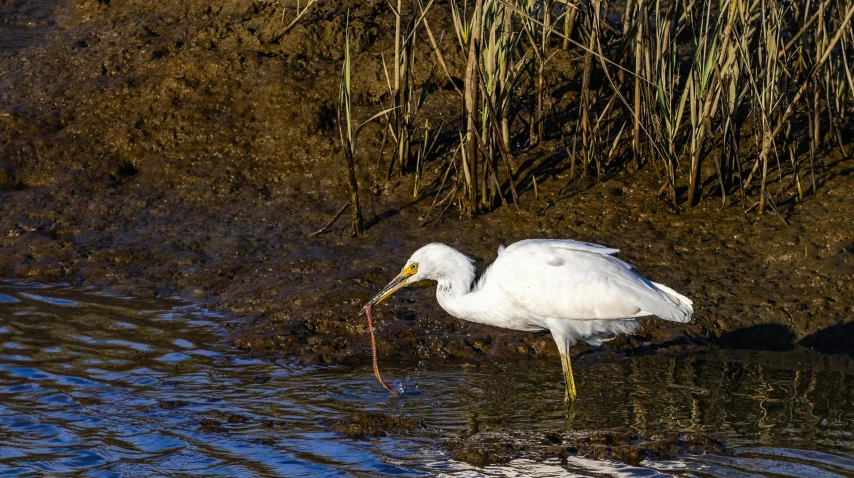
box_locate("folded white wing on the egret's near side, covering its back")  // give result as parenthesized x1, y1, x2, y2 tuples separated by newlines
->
(483, 241, 693, 322)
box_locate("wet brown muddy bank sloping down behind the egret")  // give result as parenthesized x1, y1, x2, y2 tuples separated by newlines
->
(0, 0, 854, 362)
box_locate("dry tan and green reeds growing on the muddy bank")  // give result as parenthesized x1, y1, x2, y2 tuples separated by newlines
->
(342, 0, 854, 218)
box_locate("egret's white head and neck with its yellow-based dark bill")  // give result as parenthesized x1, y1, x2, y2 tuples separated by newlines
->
(362, 243, 474, 312)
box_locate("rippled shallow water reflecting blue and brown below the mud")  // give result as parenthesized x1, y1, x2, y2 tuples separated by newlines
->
(0, 283, 854, 476)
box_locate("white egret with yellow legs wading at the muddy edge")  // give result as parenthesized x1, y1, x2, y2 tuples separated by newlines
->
(363, 239, 694, 401)
